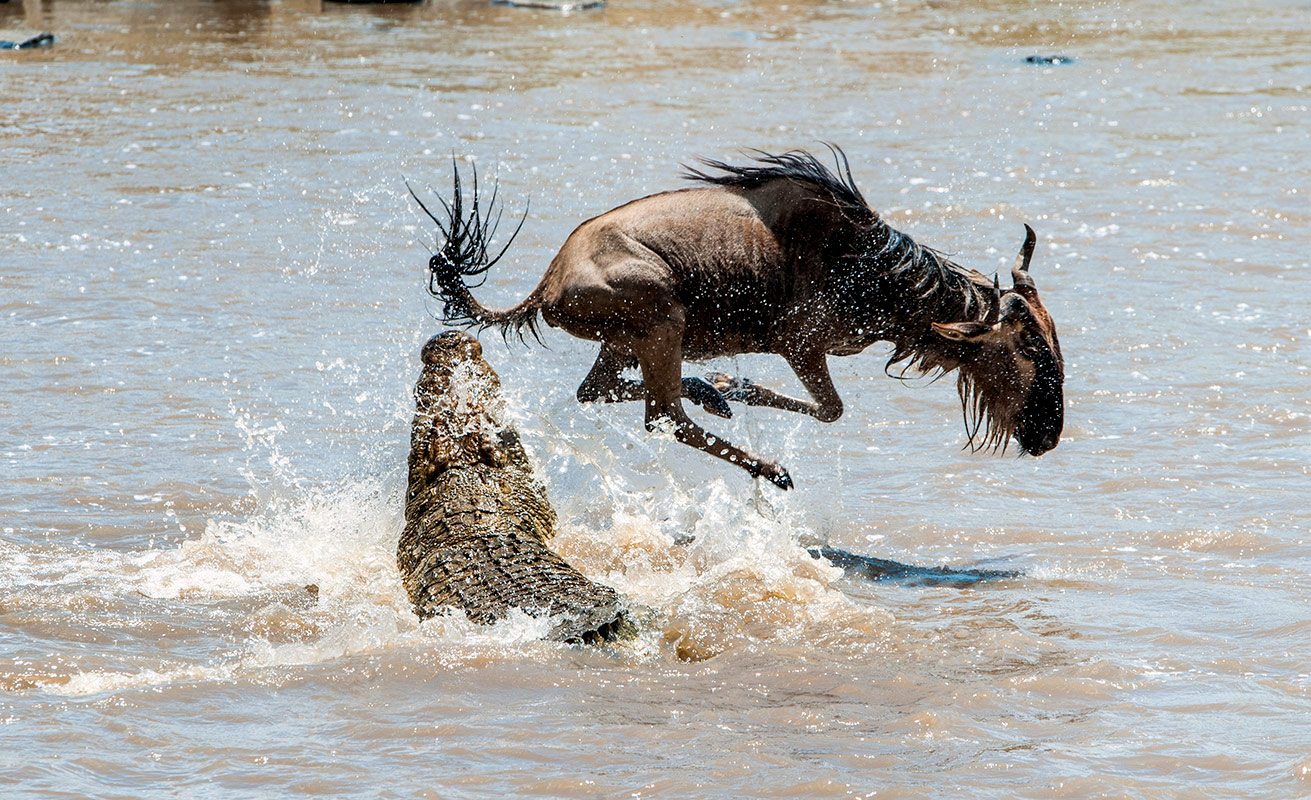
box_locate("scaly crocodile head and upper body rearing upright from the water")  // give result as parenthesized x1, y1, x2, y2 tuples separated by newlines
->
(396, 330, 631, 643)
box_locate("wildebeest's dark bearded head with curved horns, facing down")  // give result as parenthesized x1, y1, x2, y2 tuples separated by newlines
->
(933, 226, 1065, 455)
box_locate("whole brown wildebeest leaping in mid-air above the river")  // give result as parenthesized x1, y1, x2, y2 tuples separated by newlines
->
(414, 146, 1065, 489)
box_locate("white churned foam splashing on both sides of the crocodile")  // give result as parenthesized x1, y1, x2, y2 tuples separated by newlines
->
(0, 448, 888, 696)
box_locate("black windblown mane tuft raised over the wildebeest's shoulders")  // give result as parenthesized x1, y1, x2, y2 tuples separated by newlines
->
(683, 142, 877, 223)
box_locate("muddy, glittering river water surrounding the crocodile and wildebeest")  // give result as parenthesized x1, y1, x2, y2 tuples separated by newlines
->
(0, 0, 1311, 799)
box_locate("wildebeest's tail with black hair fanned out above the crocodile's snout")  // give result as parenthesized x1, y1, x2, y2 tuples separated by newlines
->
(406, 160, 541, 341)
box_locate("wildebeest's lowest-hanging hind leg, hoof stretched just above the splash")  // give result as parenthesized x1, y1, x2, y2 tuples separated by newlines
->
(635, 325, 792, 489)
